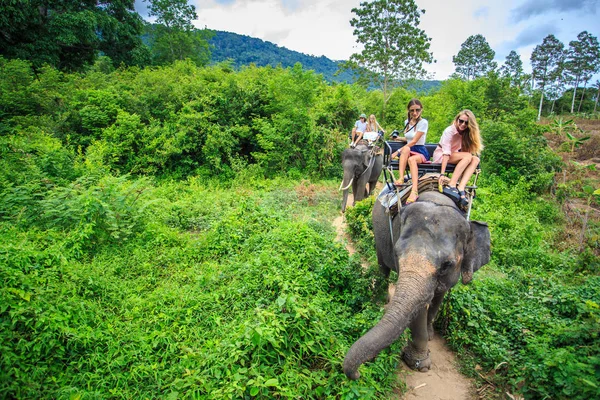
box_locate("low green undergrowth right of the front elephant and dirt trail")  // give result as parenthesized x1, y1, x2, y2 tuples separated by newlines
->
(437, 177, 600, 399)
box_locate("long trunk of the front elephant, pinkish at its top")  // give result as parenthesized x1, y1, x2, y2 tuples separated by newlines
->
(343, 255, 435, 379)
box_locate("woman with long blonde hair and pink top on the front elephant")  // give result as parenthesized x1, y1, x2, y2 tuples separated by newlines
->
(433, 110, 483, 208)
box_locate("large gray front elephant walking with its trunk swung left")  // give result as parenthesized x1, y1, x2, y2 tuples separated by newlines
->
(343, 191, 490, 379)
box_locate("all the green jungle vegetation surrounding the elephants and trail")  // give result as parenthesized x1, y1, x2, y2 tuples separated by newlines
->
(0, 1, 600, 399)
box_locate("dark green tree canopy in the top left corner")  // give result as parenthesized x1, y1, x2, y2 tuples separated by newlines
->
(0, 0, 148, 71)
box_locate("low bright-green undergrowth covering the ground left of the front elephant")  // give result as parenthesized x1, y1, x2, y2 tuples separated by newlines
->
(0, 177, 399, 398)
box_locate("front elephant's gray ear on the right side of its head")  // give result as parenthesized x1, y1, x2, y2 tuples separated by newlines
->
(462, 221, 491, 284)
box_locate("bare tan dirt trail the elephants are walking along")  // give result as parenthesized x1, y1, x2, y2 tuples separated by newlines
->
(333, 196, 478, 400)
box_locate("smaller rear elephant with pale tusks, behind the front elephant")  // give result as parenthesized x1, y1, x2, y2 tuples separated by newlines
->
(340, 144, 383, 212)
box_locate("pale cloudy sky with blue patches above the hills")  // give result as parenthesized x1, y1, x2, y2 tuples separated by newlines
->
(136, 0, 600, 80)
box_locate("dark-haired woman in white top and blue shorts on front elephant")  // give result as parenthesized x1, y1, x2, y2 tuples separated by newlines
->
(392, 99, 429, 204)
